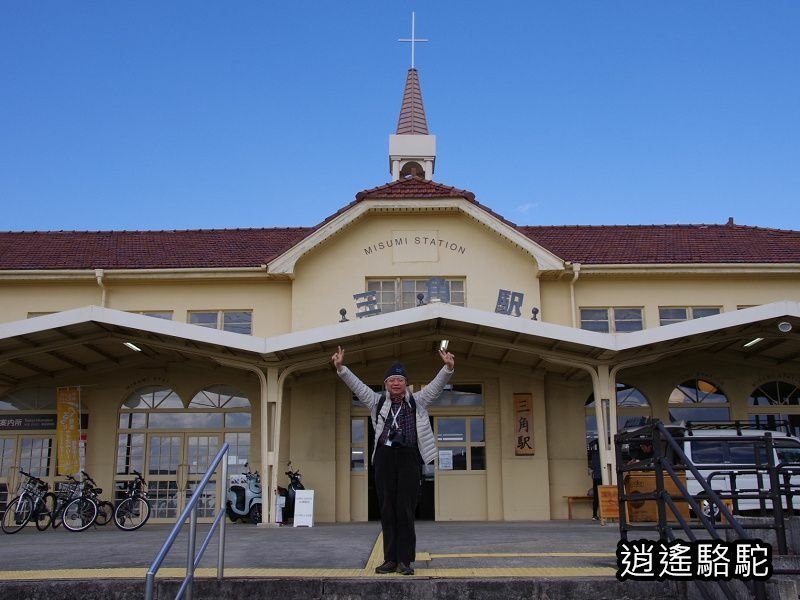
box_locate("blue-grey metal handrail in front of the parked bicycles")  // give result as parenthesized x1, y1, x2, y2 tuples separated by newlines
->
(144, 442, 230, 600)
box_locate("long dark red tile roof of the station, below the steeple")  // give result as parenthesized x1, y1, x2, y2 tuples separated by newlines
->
(0, 177, 800, 270)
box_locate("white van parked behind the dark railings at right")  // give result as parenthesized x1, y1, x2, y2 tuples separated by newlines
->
(669, 423, 800, 516)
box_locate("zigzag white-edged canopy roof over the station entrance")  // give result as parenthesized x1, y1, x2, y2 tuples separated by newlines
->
(0, 302, 800, 391)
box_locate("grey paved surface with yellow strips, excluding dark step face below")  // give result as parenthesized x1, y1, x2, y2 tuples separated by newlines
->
(0, 521, 619, 580)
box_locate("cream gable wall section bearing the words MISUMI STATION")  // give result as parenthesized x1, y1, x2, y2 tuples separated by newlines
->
(292, 214, 539, 330)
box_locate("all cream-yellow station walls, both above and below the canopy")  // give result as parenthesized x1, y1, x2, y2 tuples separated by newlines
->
(0, 204, 800, 522)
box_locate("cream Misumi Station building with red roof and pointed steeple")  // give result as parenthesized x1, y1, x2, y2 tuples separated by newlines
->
(0, 69, 800, 522)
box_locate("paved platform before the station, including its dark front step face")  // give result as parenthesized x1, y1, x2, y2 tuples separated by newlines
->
(0, 521, 792, 600)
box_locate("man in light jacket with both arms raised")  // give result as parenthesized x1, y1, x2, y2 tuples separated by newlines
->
(331, 346, 455, 575)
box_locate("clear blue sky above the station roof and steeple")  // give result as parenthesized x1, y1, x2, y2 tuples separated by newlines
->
(0, 0, 800, 231)
